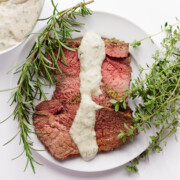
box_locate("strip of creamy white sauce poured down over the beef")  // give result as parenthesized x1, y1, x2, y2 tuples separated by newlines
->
(70, 32, 105, 161)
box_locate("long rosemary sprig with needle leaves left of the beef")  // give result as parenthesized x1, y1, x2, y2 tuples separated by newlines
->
(1, 0, 94, 173)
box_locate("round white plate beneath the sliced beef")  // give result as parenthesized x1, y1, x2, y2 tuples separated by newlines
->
(12, 12, 156, 172)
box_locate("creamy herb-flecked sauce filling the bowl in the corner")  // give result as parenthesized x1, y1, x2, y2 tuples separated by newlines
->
(0, 0, 43, 51)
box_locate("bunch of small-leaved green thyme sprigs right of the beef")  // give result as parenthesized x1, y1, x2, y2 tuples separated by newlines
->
(111, 21, 180, 172)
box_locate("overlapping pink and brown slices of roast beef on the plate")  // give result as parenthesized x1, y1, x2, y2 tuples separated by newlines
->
(33, 39, 136, 160)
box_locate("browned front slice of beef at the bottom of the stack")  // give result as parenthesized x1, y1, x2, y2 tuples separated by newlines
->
(33, 100, 133, 160)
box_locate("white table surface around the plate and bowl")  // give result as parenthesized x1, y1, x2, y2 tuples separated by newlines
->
(0, 0, 180, 180)
